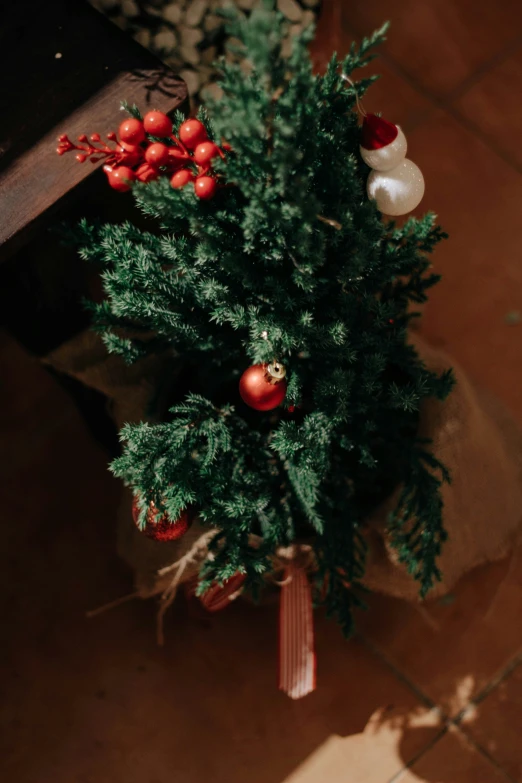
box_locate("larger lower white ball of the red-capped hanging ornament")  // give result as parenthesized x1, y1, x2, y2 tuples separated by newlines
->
(366, 159, 424, 217)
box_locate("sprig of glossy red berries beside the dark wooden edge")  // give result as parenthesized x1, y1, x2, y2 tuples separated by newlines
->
(56, 111, 224, 200)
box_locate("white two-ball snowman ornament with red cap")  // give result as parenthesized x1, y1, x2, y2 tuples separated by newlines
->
(359, 113, 424, 217)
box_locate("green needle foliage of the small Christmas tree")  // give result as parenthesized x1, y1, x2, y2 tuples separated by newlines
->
(72, 2, 452, 632)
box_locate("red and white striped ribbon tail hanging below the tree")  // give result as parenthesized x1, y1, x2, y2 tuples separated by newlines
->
(279, 563, 316, 699)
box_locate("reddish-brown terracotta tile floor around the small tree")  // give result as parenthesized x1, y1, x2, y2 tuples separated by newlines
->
(0, 0, 522, 783)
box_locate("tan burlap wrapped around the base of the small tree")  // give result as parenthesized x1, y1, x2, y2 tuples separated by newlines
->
(46, 333, 522, 600)
